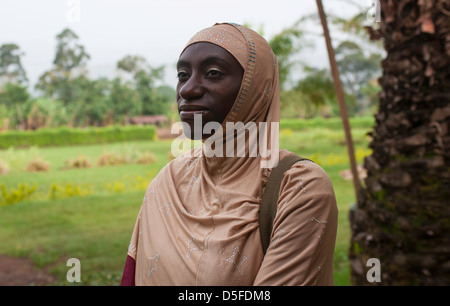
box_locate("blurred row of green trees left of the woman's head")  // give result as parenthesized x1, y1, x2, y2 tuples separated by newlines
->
(0, 29, 175, 129)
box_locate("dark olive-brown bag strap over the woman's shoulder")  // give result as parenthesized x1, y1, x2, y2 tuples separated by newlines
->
(259, 154, 307, 254)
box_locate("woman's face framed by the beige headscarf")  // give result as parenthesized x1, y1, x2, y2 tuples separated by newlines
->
(177, 42, 244, 139)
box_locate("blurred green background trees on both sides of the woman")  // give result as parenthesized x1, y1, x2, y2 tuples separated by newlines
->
(0, 7, 381, 129)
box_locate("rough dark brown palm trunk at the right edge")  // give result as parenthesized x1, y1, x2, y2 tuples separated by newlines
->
(349, 0, 450, 285)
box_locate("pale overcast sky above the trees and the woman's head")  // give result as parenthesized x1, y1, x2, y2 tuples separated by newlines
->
(0, 0, 367, 90)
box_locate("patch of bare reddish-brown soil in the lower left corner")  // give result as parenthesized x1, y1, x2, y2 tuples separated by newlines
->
(0, 255, 56, 286)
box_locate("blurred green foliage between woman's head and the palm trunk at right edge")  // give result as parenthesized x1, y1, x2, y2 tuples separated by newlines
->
(270, 5, 383, 118)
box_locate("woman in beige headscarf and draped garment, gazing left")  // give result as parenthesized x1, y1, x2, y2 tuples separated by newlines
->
(122, 23, 337, 285)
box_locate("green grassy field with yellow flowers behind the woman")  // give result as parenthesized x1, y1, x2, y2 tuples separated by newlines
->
(0, 118, 371, 286)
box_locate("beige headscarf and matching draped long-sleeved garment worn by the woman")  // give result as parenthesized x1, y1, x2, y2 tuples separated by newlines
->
(123, 23, 336, 285)
